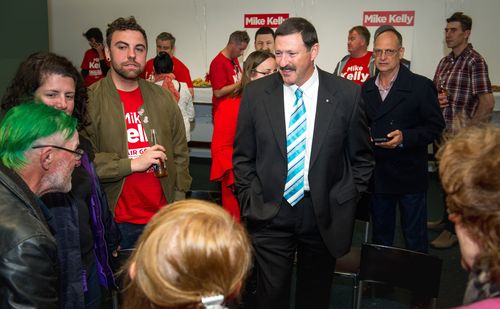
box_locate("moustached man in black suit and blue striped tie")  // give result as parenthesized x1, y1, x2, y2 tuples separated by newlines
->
(233, 18, 374, 309)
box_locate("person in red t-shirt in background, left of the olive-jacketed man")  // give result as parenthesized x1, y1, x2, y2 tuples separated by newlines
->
(80, 28, 109, 87)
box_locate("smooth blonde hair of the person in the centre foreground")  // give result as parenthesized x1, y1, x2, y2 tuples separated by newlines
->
(123, 200, 251, 308)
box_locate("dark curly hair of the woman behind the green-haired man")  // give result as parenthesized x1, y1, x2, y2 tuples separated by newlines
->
(1, 52, 89, 129)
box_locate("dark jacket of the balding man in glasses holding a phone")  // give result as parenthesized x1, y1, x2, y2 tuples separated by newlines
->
(362, 66, 445, 194)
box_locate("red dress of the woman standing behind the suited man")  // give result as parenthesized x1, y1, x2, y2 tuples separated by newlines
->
(210, 97, 241, 222)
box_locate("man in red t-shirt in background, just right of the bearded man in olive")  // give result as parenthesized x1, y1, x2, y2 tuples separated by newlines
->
(141, 32, 194, 96)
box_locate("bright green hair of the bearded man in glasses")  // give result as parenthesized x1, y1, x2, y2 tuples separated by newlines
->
(0, 102, 78, 171)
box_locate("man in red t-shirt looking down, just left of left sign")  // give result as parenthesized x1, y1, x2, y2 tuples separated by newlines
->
(208, 31, 250, 115)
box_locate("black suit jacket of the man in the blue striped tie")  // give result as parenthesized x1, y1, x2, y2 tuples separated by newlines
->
(233, 69, 374, 257)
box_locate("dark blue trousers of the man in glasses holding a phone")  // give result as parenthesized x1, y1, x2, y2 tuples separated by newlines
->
(372, 192, 429, 252)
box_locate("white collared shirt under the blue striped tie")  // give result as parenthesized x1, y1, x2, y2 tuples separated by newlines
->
(283, 66, 319, 191)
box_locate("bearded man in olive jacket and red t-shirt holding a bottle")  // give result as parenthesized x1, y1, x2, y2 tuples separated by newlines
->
(82, 17, 191, 248)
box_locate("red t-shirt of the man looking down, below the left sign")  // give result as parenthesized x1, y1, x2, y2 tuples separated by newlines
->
(209, 53, 242, 115)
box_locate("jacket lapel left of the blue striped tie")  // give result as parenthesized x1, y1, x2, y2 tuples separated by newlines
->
(263, 73, 287, 158)
